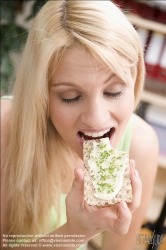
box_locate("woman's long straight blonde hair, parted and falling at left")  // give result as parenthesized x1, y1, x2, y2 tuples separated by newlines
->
(5, 0, 144, 233)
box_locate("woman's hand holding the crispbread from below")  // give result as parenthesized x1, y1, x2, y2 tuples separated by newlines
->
(66, 160, 142, 238)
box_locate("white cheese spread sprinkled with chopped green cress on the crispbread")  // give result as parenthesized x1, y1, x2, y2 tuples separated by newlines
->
(88, 138, 128, 200)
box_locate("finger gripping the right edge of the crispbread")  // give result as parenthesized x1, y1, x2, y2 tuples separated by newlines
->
(128, 160, 142, 213)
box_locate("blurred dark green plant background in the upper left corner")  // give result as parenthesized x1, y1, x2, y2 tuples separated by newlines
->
(0, 0, 47, 96)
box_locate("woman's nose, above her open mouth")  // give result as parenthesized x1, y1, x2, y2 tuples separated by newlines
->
(81, 101, 110, 128)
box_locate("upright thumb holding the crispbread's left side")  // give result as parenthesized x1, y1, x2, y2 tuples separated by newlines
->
(68, 168, 84, 205)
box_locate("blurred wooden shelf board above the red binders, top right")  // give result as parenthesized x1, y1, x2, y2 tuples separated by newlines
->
(126, 14, 166, 35)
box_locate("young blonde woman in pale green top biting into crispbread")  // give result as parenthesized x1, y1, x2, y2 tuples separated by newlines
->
(1, 0, 158, 250)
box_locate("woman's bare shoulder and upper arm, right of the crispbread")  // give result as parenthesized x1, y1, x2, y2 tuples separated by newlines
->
(130, 115, 159, 207)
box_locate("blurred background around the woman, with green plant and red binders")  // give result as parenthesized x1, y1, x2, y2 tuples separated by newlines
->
(0, 0, 166, 250)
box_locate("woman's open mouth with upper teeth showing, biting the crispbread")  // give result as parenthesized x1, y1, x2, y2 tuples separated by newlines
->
(78, 127, 115, 141)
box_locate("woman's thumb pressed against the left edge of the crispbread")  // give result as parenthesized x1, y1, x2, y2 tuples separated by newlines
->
(66, 168, 84, 209)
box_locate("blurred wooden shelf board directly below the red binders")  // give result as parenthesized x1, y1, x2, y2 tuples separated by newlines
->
(141, 90, 166, 109)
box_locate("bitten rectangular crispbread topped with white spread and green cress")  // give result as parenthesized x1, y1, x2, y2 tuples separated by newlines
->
(83, 138, 132, 206)
